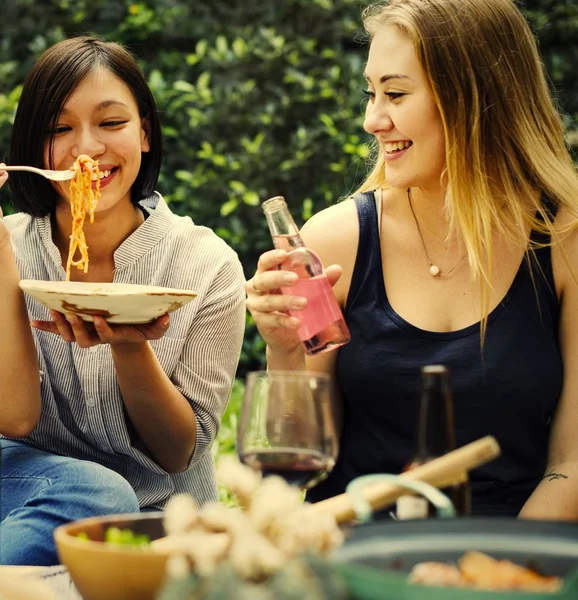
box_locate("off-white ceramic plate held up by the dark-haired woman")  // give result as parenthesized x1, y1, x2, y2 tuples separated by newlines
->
(20, 279, 197, 323)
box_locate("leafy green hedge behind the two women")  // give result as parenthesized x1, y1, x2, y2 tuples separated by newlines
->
(0, 0, 578, 460)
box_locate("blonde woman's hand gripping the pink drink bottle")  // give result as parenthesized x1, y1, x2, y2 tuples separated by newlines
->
(245, 250, 341, 354)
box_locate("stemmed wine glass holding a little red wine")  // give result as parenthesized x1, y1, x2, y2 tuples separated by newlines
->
(237, 371, 338, 489)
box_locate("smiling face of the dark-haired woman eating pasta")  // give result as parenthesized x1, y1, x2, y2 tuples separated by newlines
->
(44, 68, 150, 211)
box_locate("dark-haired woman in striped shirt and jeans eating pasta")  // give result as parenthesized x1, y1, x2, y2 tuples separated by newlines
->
(0, 37, 244, 565)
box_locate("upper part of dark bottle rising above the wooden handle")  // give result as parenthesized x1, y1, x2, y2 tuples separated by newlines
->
(415, 370, 456, 462)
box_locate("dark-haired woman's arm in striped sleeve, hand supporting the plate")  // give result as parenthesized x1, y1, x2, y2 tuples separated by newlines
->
(34, 255, 245, 473)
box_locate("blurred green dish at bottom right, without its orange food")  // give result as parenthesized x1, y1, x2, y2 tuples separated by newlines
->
(334, 517, 578, 600)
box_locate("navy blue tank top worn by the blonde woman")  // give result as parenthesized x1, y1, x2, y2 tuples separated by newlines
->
(307, 192, 563, 515)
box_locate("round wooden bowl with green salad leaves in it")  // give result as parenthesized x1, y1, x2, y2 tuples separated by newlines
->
(54, 513, 168, 600)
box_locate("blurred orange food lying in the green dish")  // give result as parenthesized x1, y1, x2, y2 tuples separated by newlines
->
(409, 552, 562, 592)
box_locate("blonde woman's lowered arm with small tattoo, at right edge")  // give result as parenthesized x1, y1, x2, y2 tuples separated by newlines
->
(520, 224, 578, 520)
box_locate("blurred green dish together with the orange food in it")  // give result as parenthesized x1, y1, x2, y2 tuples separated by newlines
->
(333, 517, 578, 600)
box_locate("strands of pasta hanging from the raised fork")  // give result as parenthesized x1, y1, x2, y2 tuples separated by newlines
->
(66, 154, 100, 281)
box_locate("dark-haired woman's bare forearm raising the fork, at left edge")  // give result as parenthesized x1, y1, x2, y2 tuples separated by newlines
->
(0, 166, 41, 438)
